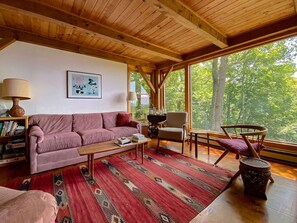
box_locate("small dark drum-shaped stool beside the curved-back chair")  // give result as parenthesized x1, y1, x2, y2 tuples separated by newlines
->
(239, 157, 271, 200)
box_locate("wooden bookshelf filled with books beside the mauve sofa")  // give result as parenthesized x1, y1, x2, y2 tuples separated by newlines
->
(0, 116, 29, 166)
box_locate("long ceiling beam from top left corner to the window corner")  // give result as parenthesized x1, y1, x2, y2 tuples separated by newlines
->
(0, 0, 182, 62)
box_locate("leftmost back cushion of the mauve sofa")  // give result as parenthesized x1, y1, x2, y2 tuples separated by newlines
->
(29, 114, 72, 135)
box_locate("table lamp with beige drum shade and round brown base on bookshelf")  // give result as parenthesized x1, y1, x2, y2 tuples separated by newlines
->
(2, 78, 31, 117)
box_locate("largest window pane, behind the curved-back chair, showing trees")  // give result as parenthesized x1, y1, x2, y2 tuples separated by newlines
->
(191, 38, 297, 143)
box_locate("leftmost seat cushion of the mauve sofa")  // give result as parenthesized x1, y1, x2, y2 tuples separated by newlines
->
(37, 132, 81, 154)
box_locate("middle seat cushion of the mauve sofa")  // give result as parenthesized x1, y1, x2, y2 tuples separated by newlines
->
(78, 129, 114, 145)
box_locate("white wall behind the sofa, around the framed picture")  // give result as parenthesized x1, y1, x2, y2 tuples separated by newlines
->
(0, 42, 127, 115)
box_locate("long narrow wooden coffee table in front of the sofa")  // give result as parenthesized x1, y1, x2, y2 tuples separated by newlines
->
(77, 138, 151, 179)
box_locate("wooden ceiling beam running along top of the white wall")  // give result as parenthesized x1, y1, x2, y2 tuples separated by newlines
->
(0, 27, 156, 69)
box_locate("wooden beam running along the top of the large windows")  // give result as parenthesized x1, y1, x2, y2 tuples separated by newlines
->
(157, 16, 297, 70)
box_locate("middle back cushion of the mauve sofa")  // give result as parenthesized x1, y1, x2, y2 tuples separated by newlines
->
(73, 113, 103, 132)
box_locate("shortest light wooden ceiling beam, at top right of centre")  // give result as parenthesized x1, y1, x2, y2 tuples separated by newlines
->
(143, 0, 228, 48)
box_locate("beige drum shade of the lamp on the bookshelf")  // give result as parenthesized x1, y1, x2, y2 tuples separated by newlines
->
(2, 78, 31, 100)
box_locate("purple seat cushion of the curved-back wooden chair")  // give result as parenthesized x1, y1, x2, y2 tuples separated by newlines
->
(217, 139, 264, 156)
